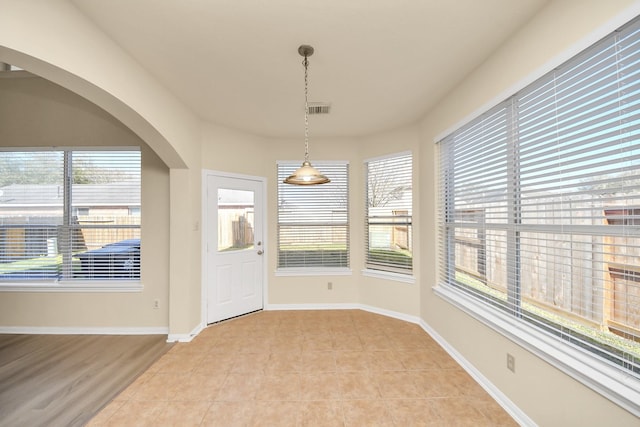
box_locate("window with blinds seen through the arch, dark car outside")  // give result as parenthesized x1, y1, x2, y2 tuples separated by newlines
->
(0, 148, 141, 283)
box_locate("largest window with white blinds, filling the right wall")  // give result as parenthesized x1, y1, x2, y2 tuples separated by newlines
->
(439, 15, 640, 375)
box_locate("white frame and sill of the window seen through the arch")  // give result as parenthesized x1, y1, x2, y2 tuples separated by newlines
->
(0, 146, 143, 293)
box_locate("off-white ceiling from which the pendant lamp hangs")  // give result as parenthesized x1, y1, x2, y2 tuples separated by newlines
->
(71, 0, 547, 137)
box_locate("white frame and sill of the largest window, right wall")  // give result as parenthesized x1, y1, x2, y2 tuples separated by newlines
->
(434, 16, 640, 416)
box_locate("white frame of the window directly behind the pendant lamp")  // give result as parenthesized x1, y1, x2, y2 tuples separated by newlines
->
(275, 160, 352, 277)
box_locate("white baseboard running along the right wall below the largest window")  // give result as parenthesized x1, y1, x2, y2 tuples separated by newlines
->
(418, 319, 537, 427)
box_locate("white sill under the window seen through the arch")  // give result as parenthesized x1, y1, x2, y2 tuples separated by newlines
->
(0, 280, 143, 292)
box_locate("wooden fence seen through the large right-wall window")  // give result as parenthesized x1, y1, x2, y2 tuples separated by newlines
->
(455, 202, 640, 340)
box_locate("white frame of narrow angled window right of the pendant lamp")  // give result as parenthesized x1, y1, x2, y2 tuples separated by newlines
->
(362, 150, 415, 283)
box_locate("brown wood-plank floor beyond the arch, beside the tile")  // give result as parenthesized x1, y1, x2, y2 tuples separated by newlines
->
(0, 334, 172, 427)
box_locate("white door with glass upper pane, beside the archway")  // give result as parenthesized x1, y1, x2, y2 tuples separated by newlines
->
(206, 175, 264, 323)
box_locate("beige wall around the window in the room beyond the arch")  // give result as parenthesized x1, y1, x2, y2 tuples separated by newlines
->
(0, 77, 169, 330)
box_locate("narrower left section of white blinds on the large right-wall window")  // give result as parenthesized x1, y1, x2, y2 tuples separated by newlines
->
(440, 106, 512, 308)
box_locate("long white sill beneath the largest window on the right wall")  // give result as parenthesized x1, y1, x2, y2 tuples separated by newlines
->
(434, 285, 640, 416)
